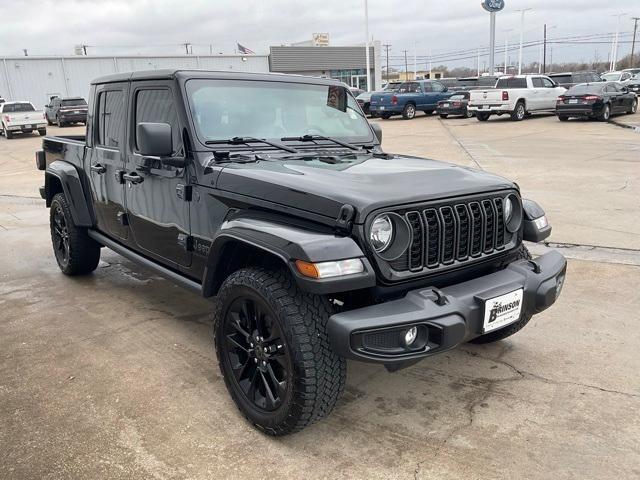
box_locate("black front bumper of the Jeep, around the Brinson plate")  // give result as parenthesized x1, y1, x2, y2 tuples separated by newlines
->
(327, 251, 567, 364)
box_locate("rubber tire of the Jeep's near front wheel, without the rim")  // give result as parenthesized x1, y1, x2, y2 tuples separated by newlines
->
(213, 268, 346, 436)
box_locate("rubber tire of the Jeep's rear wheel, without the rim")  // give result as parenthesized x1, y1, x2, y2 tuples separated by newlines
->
(49, 193, 100, 276)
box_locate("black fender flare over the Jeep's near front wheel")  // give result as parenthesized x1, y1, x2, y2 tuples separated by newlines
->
(201, 217, 376, 297)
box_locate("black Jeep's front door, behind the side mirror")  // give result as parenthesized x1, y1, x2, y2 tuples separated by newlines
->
(125, 81, 192, 266)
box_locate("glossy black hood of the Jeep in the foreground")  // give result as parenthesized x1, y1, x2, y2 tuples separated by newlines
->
(217, 154, 514, 223)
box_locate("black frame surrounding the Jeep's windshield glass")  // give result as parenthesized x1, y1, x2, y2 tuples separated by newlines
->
(180, 76, 377, 151)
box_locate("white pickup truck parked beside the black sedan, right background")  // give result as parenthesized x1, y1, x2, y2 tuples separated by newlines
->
(467, 75, 567, 122)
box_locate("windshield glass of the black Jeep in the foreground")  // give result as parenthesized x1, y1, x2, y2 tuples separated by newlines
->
(186, 79, 373, 142)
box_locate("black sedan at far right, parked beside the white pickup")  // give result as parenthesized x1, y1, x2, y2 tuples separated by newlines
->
(556, 82, 638, 122)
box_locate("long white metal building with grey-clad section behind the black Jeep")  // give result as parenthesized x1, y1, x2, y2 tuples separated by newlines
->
(0, 42, 382, 108)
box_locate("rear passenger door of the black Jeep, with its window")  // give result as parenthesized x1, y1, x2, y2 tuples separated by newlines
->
(89, 83, 129, 239)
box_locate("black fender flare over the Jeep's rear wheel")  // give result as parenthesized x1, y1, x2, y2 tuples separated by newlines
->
(44, 160, 94, 227)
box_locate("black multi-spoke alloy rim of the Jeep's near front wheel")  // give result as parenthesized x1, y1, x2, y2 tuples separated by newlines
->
(223, 291, 293, 412)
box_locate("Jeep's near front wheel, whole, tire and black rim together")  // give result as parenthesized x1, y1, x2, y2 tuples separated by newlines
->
(213, 268, 346, 436)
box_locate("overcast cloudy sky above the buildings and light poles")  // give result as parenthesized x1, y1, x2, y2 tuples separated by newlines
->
(0, 0, 640, 68)
